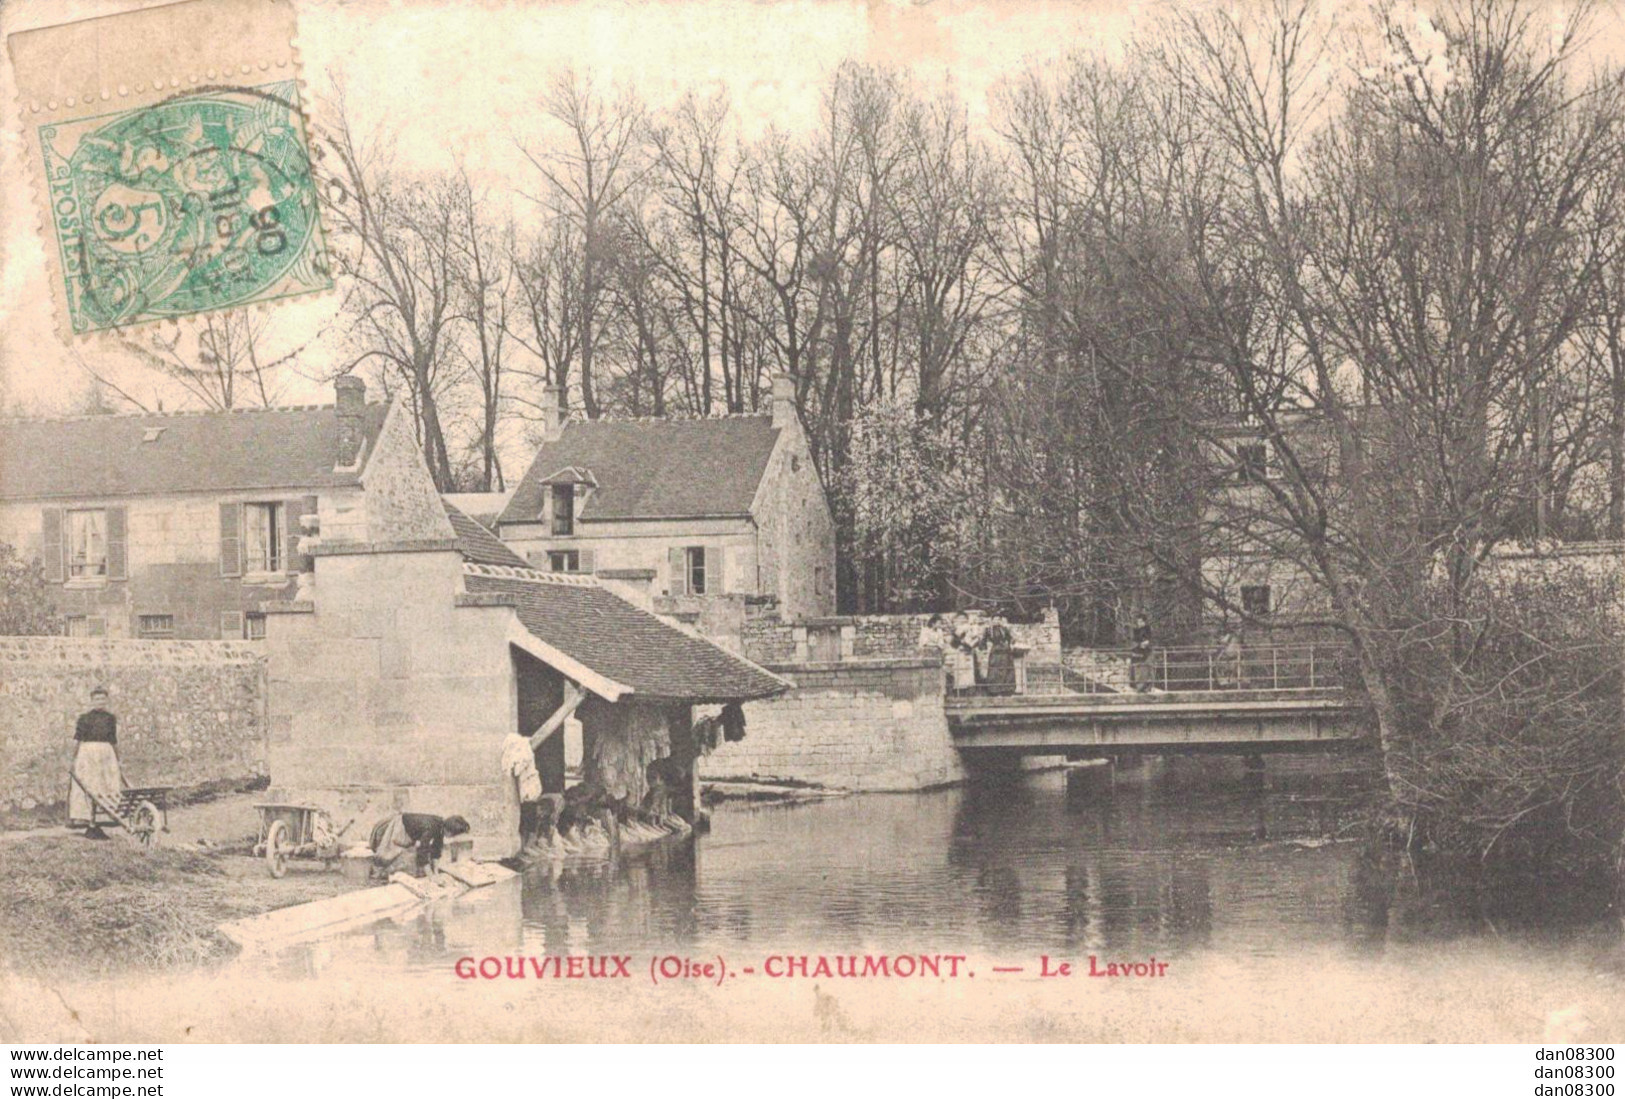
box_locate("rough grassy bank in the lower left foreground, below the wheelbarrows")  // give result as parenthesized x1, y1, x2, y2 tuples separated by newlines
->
(0, 832, 349, 975)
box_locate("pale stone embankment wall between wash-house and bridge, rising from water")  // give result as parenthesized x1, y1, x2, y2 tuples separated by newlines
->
(699, 657, 965, 790)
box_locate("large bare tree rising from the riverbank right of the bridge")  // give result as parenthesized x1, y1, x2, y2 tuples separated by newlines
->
(1167, 0, 1620, 832)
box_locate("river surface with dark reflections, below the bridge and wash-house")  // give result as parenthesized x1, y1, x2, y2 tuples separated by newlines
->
(266, 756, 1612, 972)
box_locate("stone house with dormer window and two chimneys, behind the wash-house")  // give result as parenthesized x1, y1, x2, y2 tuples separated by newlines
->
(496, 377, 835, 618)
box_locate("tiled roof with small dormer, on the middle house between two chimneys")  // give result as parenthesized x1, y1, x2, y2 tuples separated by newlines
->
(501, 416, 778, 523)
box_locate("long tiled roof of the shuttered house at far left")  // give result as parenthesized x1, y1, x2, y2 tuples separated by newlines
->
(0, 405, 388, 499)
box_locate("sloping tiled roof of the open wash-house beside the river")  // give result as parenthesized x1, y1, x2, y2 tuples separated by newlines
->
(463, 566, 787, 702)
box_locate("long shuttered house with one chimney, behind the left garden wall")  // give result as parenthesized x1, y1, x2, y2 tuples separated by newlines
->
(0, 376, 450, 641)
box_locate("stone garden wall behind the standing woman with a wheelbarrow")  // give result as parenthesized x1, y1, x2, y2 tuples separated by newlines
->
(0, 637, 267, 811)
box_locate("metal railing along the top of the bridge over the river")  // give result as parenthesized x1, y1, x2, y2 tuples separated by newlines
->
(952, 644, 1347, 696)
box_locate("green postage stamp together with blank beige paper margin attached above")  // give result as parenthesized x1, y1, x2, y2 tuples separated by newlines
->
(5, 0, 323, 337)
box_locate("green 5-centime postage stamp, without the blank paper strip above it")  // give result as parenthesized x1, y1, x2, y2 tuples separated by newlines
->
(37, 80, 333, 333)
